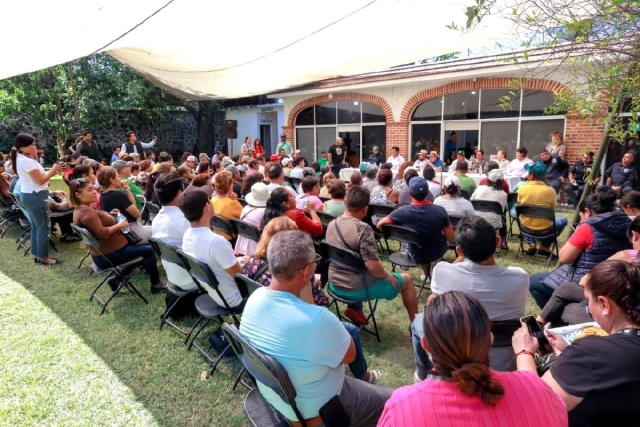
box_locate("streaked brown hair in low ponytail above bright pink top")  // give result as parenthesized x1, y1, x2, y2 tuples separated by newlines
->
(423, 291, 504, 405)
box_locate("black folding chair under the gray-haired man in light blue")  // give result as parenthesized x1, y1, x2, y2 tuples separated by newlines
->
(222, 323, 350, 427)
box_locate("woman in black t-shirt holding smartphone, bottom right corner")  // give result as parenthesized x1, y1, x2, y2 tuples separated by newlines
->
(512, 260, 640, 426)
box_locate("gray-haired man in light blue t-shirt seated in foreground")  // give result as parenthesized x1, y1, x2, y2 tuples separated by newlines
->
(240, 230, 392, 426)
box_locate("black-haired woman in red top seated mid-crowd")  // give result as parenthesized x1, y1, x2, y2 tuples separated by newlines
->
(260, 187, 323, 237)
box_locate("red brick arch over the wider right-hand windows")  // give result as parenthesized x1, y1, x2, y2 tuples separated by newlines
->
(400, 77, 567, 122)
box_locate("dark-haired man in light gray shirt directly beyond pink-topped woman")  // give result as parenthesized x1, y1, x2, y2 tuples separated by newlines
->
(411, 215, 529, 381)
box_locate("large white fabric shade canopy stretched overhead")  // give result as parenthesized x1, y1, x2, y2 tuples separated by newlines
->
(0, 0, 513, 99)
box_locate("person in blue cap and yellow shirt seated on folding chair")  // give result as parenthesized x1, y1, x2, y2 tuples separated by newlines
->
(518, 162, 567, 256)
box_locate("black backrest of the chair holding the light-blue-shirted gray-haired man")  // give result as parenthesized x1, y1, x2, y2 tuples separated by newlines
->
(222, 323, 304, 420)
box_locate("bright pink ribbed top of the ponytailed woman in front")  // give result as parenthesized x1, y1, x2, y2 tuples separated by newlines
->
(378, 370, 569, 427)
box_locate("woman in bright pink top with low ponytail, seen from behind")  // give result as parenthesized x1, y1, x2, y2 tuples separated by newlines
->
(378, 292, 568, 427)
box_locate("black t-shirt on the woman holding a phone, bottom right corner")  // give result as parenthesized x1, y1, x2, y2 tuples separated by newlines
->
(551, 334, 640, 427)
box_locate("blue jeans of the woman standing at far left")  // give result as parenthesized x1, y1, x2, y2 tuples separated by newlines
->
(20, 190, 49, 259)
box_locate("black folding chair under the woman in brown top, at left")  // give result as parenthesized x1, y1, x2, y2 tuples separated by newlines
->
(71, 224, 149, 316)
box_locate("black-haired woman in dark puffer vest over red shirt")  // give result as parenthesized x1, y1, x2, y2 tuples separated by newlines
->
(529, 188, 631, 308)
